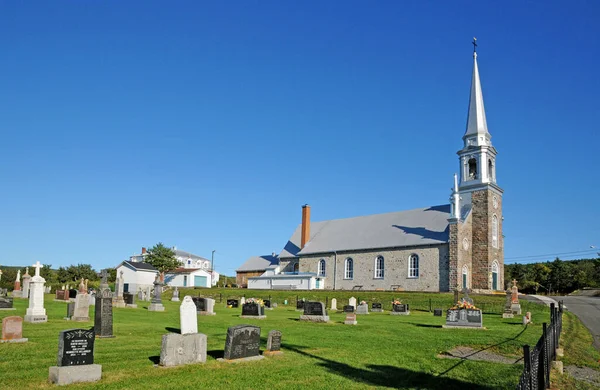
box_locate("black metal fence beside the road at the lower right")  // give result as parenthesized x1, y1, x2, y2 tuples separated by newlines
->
(517, 301, 563, 390)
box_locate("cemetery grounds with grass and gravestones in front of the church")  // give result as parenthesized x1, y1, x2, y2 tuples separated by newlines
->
(0, 286, 568, 389)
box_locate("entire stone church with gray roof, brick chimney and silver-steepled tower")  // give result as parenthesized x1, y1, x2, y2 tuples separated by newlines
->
(241, 45, 504, 292)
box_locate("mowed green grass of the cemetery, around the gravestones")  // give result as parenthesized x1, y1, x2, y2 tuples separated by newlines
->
(0, 291, 549, 390)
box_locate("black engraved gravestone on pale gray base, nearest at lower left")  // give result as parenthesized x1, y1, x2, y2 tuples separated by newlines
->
(48, 329, 102, 385)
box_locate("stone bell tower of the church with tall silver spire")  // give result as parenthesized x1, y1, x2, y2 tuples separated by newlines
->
(450, 38, 504, 290)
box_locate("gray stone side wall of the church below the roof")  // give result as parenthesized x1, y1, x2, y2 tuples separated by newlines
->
(300, 244, 449, 291)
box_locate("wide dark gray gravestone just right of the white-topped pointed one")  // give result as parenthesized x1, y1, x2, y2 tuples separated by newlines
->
(223, 325, 264, 361)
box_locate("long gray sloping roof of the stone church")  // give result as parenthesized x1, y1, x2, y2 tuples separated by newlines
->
(279, 205, 450, 258)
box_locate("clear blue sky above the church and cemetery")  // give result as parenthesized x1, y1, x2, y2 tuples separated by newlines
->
(0, 1, 600, 275)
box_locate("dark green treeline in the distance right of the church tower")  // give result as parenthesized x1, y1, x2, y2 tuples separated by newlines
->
(504, 258, 600, 294)
